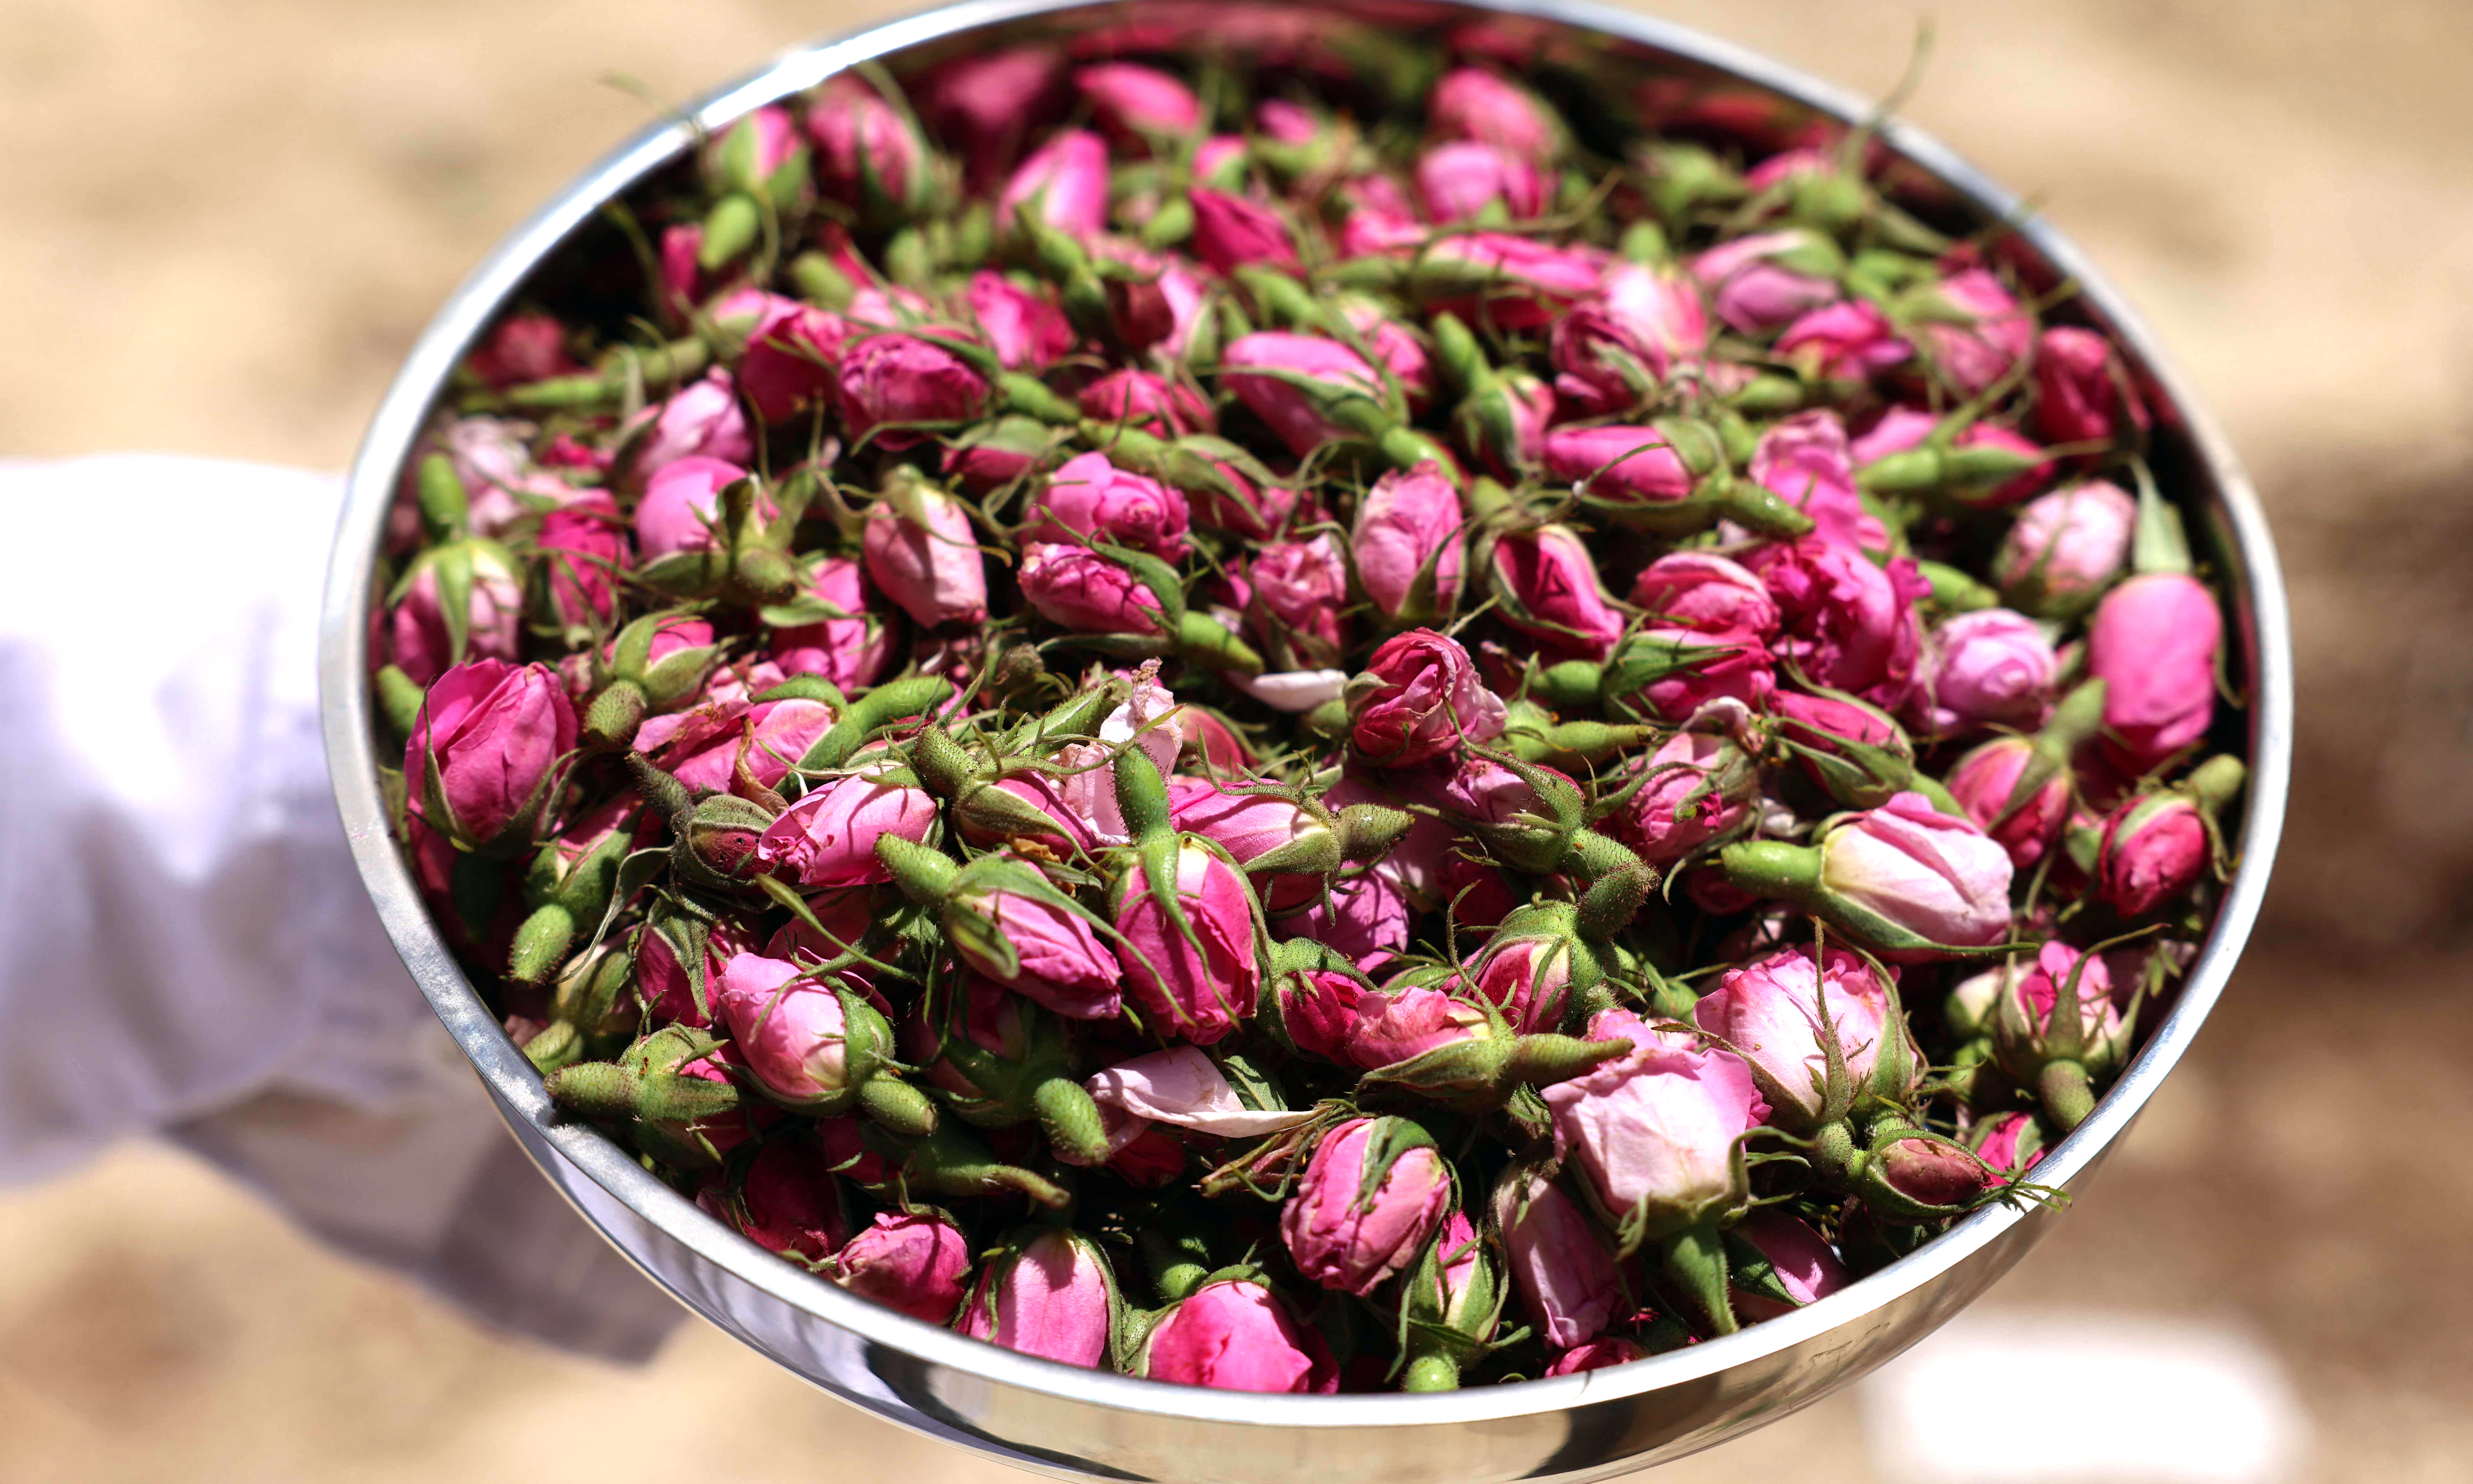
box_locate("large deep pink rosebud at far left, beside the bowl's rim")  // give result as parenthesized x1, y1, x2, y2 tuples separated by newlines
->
(403, 660, 576, 853)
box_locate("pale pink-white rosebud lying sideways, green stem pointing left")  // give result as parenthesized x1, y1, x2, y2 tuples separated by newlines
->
(1820, 794, 2010, 962)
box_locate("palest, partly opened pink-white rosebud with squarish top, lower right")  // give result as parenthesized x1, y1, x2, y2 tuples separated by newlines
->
(1541, 1009, 1768, 1227)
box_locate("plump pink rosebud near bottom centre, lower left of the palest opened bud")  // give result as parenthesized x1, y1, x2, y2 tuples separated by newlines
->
(1278, 1118, 1452, 1298)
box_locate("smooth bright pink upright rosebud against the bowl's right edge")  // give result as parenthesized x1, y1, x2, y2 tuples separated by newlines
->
(2087, 571, 2223, 774)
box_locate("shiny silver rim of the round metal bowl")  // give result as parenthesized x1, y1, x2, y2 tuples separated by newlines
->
(319, 0, 2292, 1430)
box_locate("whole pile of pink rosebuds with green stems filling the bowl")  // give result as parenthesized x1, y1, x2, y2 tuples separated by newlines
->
(373, 35, 2243, 1393)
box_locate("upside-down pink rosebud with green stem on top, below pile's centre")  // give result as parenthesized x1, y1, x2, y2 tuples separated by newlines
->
(1115, 843, 1261, 1046)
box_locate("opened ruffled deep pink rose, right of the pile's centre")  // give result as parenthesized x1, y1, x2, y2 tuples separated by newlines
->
(1743, 537, 1929, 710)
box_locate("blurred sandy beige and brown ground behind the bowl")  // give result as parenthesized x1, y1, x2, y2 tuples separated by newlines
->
(0, 0, 2473, 1484)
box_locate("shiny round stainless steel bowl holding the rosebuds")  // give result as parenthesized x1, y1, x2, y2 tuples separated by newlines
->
(321, 0, 2292, 1484)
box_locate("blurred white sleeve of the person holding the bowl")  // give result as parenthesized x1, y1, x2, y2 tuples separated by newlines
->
(0, 455, 680, 1355)
